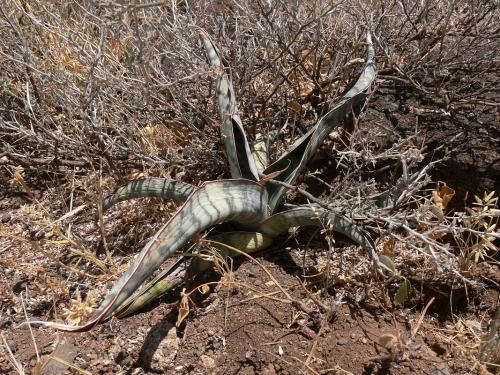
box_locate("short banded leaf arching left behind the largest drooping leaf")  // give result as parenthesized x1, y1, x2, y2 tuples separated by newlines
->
(103, 177, 196, 211)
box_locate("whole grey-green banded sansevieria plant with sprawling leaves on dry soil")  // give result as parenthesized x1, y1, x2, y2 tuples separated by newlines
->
(30, 31, 376, 332)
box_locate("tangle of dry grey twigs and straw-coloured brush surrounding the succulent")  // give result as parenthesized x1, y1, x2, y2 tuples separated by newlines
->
(0, 0, 500, 373)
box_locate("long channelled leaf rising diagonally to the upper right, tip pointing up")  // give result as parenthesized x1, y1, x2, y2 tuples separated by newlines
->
(264, 34, 375, 212)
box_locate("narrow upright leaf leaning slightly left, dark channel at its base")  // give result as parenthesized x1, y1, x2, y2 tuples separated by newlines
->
(202, 32, 259, 181)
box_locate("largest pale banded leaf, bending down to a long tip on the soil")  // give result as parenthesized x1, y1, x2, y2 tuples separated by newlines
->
(32, 179, 268, 332)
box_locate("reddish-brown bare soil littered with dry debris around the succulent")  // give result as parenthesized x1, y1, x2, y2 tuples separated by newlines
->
(0, 84, 500, 375)
